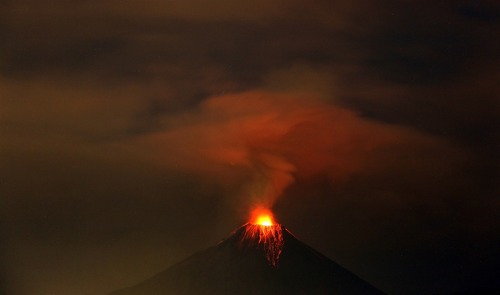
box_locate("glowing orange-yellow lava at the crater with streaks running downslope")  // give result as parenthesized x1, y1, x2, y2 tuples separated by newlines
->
(241, 209, 283, 267)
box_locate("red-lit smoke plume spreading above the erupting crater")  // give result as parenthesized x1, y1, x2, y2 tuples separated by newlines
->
(133, 91, 446, 206)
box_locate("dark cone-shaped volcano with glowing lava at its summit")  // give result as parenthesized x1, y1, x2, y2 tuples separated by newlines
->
(110, 212, 384, 295)
